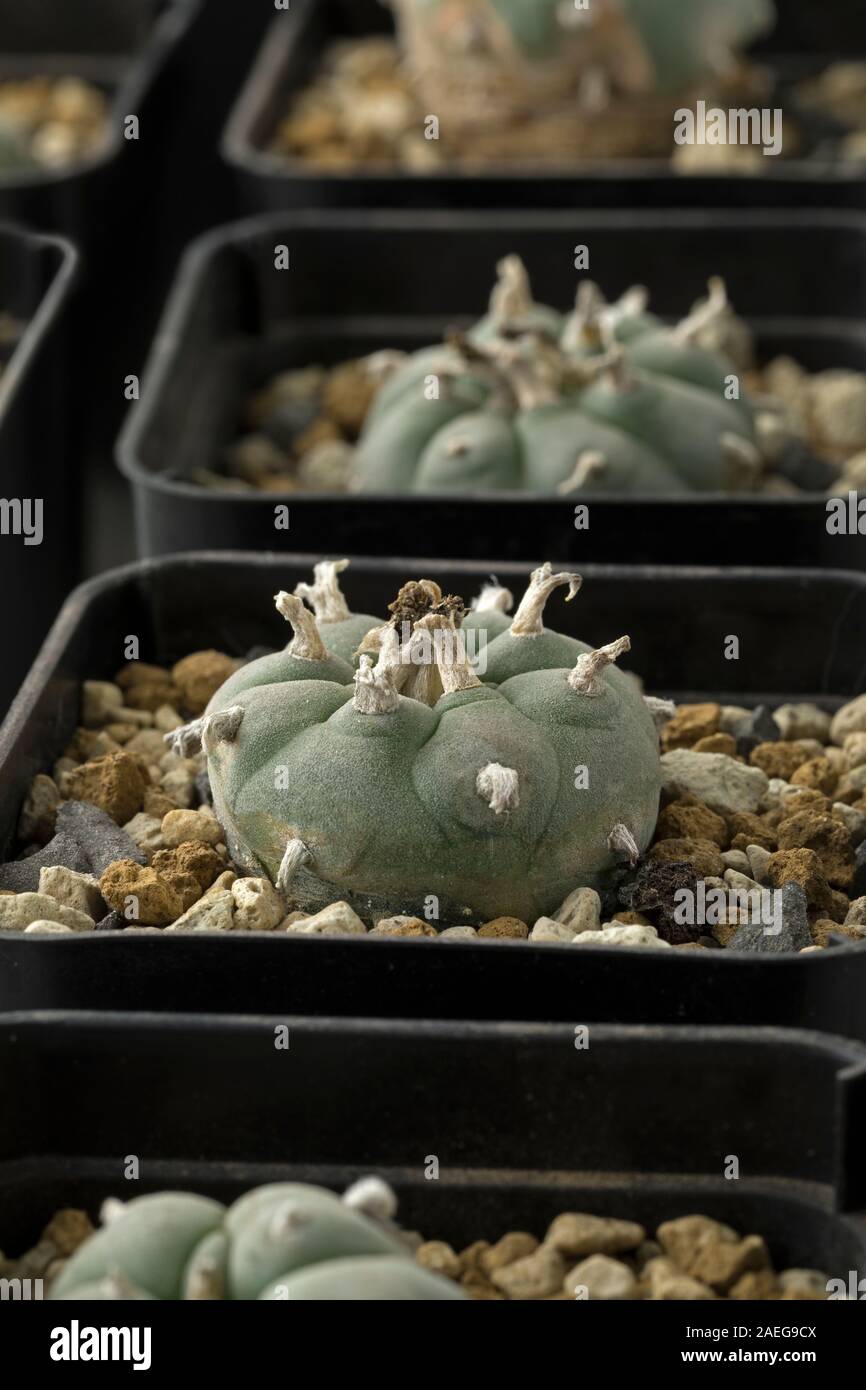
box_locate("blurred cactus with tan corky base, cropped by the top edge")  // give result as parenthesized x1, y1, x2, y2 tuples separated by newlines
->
(391, 0, 774, 128)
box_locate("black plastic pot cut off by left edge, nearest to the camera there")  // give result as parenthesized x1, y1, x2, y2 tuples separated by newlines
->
(0, 224, 79, 710)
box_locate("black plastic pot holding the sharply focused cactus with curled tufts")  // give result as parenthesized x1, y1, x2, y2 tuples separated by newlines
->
(0, 555, 866, 1040)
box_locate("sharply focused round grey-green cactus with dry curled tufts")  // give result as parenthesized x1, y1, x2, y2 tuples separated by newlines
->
(172, 562, 660, 923)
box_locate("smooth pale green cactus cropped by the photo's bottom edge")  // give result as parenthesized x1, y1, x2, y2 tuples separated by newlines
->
(51, 1179, 466, 1301)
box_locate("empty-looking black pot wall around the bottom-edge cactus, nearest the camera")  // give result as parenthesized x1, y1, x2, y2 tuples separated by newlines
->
(0, 1013, 866, 1277)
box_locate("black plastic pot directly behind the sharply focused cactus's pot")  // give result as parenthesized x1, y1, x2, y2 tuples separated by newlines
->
(118, 213, 866, 569)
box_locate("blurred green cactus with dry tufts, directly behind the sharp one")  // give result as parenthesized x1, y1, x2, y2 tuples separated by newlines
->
(354, 256, 762, 496)
